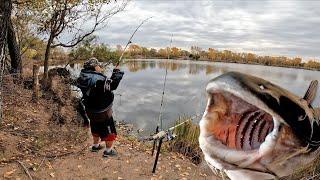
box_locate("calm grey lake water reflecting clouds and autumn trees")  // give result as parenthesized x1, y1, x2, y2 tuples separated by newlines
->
(70, 60, 320, 132)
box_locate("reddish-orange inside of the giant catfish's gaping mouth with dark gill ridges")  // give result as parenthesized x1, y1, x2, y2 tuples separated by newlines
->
(205, 91, 274, 151)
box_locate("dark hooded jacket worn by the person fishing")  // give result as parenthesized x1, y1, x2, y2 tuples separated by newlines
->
(77, 69, 124, 113)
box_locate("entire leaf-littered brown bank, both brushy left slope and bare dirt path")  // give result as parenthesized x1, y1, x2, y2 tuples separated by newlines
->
(0, 73, 216, 180)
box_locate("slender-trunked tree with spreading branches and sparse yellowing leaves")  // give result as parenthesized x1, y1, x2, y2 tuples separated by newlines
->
(28, 0, 127, 82)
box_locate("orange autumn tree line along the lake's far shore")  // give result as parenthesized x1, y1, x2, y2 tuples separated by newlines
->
(116, 44, 320, 70)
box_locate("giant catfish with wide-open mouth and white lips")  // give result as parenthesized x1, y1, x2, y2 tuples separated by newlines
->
(199, 72, 320, 179)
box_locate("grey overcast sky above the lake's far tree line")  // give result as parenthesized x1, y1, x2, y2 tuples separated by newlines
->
(96, 0, 320, 59)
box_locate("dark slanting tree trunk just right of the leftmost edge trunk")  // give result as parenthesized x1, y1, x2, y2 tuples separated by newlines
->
(7, 16, 22, 77)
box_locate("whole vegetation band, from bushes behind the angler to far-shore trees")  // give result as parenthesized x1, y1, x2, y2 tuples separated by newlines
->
(24, 37, 320, 71)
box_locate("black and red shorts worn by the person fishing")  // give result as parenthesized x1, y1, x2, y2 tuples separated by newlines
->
(87, 108, 117, 141)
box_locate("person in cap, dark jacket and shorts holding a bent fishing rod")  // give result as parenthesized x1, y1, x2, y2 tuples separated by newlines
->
(78, 58, 124, 157)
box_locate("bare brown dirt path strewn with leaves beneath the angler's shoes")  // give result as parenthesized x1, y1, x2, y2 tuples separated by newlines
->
(0, 129, 215, 180)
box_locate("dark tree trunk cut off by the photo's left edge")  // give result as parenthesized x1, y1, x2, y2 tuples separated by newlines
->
(0, 0, 12, 122)
